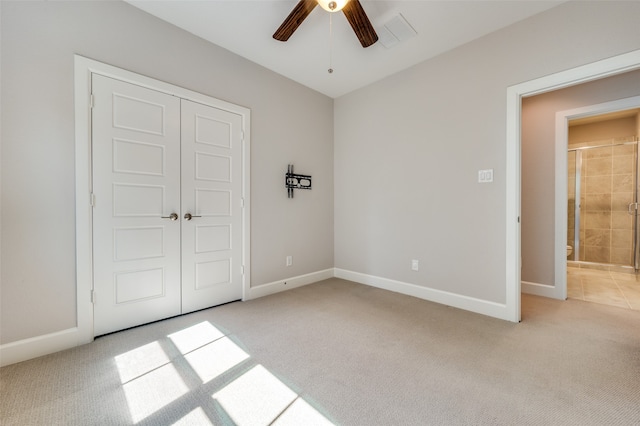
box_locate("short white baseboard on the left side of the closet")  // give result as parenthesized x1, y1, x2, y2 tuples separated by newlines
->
(0, 327, 80, 367)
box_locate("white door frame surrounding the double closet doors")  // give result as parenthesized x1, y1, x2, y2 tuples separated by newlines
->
(74, 55, 251, 344)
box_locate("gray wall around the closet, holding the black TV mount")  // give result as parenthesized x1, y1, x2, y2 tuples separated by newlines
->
(0, 1, 333, 343)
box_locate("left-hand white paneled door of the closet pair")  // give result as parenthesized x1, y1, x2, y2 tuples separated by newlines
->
(92, 74, 181, 336)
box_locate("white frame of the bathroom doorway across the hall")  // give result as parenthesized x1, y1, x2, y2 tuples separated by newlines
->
(548, 96, 640, 300)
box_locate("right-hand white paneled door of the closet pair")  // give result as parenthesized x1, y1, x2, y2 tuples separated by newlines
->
(181, 100, 243, 312)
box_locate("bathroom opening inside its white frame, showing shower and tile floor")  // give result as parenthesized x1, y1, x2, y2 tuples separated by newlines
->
(567, 108, 640, 309)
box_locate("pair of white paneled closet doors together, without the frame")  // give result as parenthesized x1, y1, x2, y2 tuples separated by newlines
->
(92, 74, 243, 336)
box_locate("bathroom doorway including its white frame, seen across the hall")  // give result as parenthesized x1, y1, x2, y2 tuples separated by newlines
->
(551, 96, 640, 302)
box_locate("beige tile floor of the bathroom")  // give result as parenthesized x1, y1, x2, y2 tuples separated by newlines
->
(567, 266, 640, 310)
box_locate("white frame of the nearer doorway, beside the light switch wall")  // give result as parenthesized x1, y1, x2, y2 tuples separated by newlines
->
(506, 50, 640, 322)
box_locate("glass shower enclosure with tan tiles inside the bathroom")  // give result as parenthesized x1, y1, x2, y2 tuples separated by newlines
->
(567, 142, 640, 269)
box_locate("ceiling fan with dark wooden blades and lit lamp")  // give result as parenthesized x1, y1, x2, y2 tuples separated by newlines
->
(273, 0, 378, 47)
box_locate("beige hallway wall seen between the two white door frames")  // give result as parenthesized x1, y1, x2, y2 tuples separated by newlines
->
(522, 70, 640, 285)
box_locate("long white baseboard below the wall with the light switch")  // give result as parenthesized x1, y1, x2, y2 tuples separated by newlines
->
(335, 268, 511, 321)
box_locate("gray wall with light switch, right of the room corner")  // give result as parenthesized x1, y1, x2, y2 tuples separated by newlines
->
(334, 2, 640, 303)
